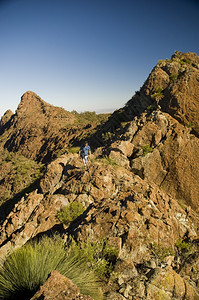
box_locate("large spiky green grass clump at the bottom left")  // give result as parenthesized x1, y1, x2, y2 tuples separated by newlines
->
(0, 236, 101, 300)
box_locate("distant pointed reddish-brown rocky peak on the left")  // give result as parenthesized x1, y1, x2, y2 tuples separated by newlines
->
(0, 91, 99, 163)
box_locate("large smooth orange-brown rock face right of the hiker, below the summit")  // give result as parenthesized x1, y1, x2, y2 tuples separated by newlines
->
(106, 110, 199, 210)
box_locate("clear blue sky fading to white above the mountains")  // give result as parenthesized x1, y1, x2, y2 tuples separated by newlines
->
(0, 0, 199, 115)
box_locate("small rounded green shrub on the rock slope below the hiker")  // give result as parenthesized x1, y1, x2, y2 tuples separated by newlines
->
(57, 201, 85, 225)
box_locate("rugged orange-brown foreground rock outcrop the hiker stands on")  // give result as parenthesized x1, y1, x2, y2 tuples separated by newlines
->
(0, 154, 199, 299)
